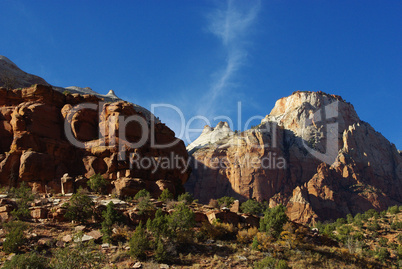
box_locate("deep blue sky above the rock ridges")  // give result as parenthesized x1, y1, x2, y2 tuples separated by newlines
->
(0, 0, 402, 149)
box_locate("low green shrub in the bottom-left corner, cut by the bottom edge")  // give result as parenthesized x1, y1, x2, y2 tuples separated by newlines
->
(2, 252, 49, 269)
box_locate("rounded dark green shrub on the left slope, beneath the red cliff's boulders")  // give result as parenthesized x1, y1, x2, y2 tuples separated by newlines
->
(64, 186, 94, 222)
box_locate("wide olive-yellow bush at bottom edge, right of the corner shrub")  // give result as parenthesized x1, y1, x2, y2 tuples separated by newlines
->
(50, 238, 105, 269)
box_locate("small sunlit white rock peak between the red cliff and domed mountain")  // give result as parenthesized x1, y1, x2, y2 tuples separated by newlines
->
(186, 121, 234, 151)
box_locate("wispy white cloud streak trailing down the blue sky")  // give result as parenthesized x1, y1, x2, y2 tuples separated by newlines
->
(197, 0, 260, 117)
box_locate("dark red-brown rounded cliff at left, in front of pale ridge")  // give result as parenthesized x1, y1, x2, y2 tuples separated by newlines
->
(0, 85, 188, 195)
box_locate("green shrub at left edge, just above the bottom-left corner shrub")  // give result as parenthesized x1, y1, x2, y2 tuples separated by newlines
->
(3, 221, 27, 253)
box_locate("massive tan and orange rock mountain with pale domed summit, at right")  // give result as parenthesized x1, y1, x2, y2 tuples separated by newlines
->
(186, 92, 402, 223)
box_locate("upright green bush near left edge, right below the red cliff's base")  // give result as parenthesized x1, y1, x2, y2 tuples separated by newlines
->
(9, 182, 35, 220)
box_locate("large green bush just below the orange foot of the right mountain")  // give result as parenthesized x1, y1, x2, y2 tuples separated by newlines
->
(260, 205, 289, 238)
